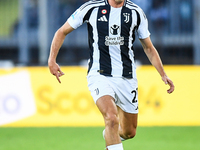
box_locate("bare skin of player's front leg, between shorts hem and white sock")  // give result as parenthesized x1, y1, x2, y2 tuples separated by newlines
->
(96, 95, 122, 150)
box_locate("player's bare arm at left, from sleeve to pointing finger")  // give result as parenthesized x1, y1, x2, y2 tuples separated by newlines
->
(48, 22, 74, 83)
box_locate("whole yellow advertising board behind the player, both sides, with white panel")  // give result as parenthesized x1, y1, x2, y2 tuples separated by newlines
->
(0, 66, 200, 127)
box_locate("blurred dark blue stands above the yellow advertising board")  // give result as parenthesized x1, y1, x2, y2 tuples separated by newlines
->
(0, 0, 200, 66)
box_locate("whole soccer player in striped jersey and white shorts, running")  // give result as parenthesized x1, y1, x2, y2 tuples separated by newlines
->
(48, 0, 174, 150)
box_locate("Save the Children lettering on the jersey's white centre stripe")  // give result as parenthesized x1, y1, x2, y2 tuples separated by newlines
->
(105, 36, 124, 46)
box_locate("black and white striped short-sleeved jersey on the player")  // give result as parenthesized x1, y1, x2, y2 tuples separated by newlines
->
(68, 0, 150, 78)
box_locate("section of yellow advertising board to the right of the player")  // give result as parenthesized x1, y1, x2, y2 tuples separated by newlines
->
(137, 66, 200, 126)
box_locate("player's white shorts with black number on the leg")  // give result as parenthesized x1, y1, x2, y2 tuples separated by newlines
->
(87, 75, 138, 114)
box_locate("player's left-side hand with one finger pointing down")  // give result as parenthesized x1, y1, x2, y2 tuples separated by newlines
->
(48, 62, 64, 83)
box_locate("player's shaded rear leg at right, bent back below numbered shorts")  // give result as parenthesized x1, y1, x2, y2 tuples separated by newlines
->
(118, 107, 138, 140)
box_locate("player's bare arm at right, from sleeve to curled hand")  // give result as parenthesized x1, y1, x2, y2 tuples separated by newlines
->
(140, 37, 174, 93)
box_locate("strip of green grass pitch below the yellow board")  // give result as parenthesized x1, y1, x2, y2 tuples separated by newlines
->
(0, 127, 200, 150)
